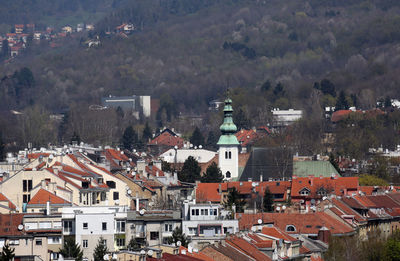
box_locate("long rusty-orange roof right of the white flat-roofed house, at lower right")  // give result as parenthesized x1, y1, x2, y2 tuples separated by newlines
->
(236, 212, 354, 235)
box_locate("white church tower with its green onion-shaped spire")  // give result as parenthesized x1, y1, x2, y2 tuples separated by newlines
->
(217, 98, 239, 180)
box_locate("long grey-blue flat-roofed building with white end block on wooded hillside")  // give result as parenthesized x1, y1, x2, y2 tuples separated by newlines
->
(101, 95, 151, 119)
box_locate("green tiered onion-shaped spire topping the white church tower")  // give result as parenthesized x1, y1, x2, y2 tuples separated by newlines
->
(217, 98, 239, 145)
